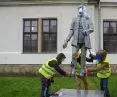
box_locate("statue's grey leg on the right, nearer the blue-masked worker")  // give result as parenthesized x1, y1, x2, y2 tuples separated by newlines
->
(80, 44, 87, 76)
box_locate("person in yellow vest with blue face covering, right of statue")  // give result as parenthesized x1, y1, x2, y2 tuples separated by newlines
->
(87, 50, 111, 97)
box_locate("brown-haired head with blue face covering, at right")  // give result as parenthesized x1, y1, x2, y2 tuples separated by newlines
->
(96, 50, 107, 61)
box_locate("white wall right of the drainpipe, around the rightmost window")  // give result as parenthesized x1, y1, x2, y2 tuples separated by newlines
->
(100, 7, 117, 64)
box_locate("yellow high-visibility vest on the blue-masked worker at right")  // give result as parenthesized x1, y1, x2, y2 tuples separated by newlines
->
(97, 58, 111, 78)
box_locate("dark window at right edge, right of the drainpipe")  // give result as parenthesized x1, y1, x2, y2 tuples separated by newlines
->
(103, 21, 117, 53)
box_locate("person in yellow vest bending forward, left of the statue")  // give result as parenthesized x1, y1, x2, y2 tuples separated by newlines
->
(38, 53, 70, 97)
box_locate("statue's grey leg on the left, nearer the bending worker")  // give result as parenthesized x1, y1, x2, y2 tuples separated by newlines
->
(71, 46, 79, 74)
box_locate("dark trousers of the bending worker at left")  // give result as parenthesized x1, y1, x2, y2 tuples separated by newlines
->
(41, 76, 51, 97)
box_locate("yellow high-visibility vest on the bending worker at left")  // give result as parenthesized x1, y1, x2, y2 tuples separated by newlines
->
(38, 58, 57, 79)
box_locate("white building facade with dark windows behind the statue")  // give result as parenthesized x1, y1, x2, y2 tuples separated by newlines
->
(0, 0, 117, 72)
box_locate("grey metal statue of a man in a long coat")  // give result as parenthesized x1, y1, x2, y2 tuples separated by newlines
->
(63, 5, 93, 76)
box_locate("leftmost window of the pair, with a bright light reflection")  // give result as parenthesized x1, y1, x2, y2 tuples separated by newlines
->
(23, 19, 38, 53)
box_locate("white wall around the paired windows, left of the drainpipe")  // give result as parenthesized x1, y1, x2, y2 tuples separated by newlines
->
(0, 6, 95, 64)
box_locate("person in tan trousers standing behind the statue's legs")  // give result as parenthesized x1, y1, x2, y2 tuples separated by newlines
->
(75, 52, 93, 90)
